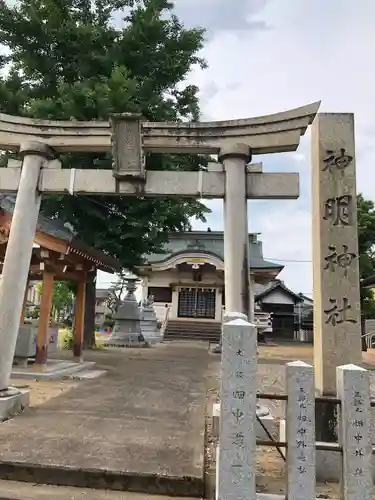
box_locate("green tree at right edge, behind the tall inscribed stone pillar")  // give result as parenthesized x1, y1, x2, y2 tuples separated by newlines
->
(357, 194, 375, 318)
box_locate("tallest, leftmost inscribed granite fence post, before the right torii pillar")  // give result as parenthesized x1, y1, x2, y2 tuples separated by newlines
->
(216, 319, 257, 500)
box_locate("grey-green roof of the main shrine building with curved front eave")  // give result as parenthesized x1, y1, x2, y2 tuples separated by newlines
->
(144, 231, 284, 271)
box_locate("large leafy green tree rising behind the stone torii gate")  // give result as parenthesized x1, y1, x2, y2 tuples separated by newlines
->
(0, 0, 207, 268)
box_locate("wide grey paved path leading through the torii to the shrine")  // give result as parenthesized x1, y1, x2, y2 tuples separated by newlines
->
(0, 343, 216, 497)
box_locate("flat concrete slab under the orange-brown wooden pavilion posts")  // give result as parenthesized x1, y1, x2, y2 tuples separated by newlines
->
(12, 359, 95, 380)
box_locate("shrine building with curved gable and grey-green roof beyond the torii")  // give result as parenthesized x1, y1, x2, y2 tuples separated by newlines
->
(138, 230, 284, 332)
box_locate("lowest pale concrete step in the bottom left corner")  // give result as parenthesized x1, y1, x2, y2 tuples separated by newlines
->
(0, 481, 197, 500)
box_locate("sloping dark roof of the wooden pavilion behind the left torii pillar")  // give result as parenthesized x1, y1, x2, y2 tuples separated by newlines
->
(0, 194, 120, 272)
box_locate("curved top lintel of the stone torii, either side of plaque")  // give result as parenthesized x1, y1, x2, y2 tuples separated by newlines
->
(0, 102, 320, 154)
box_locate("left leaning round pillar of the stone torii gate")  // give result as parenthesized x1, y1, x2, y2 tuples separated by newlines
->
(0, 142, 52, 391)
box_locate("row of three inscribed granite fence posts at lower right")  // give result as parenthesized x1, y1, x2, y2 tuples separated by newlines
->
(216, 319, 373, 500)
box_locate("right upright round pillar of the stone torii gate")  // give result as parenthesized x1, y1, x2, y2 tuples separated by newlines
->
(219, 144, 253, 319)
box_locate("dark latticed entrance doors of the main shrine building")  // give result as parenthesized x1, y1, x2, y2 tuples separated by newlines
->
(177, 288, 216, 319)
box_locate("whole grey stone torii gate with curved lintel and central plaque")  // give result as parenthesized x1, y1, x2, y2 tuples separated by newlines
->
(0, 102, 320, 394)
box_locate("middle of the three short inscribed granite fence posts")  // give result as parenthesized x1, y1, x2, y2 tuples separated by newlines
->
(286, 361, 316, 500)
